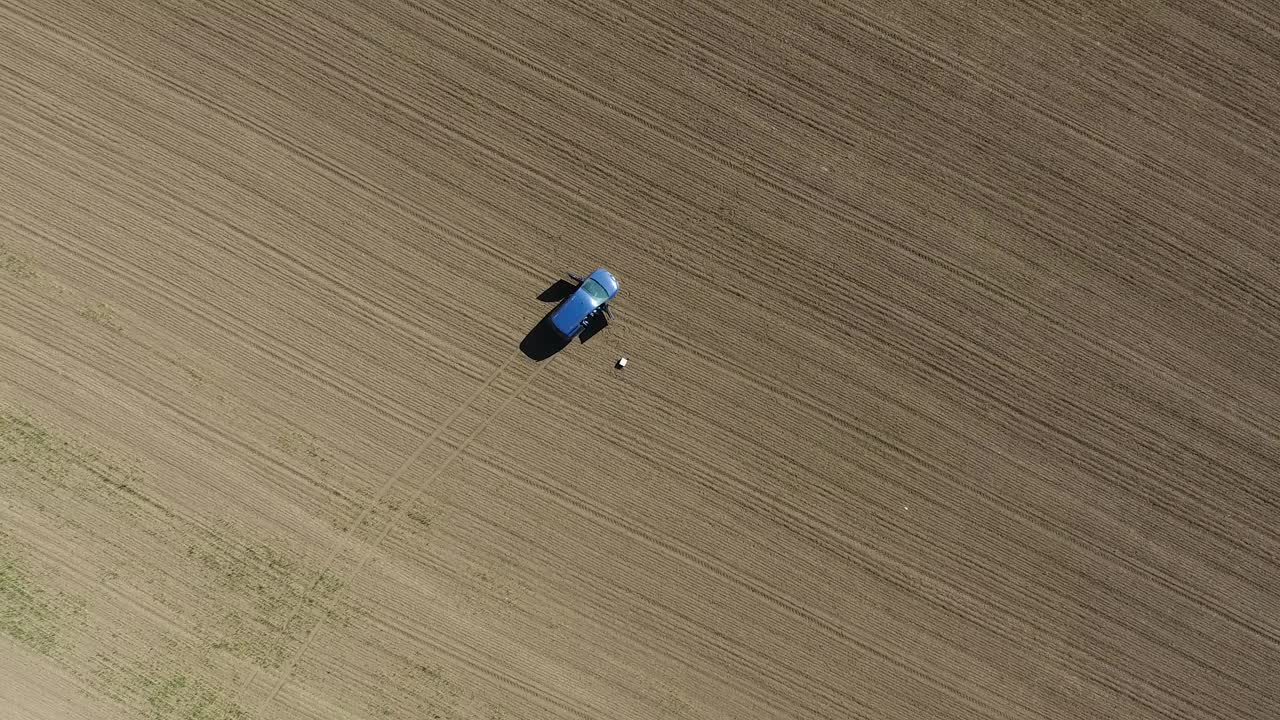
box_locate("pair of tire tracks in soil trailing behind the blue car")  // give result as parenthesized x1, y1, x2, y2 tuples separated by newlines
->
(252, 350, 556, 716)
